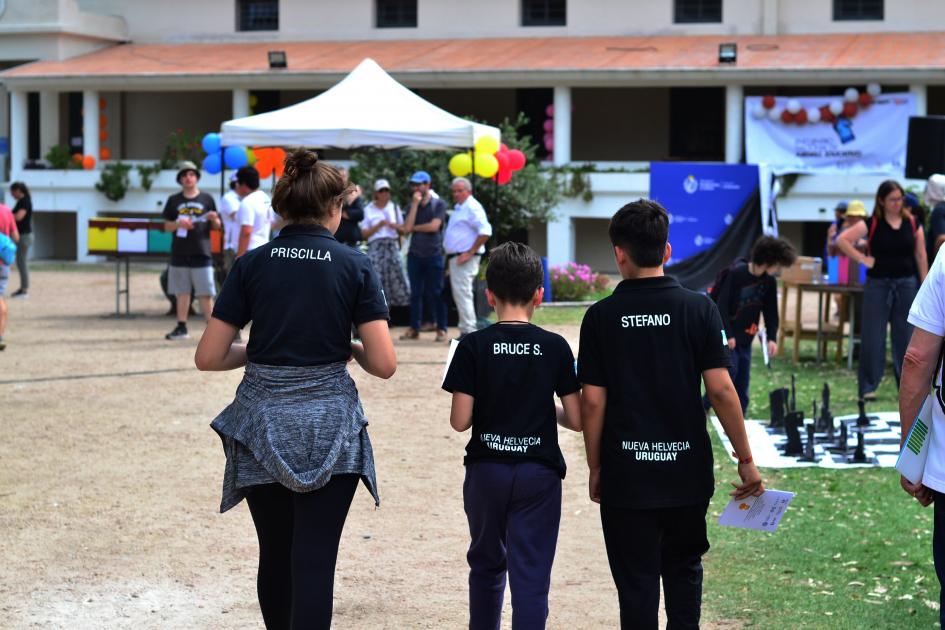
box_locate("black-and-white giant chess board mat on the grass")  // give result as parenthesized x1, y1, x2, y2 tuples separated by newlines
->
(712, 411, 901, 468)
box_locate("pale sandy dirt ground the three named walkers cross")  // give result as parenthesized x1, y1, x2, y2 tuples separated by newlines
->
(0, 265, 737, 629)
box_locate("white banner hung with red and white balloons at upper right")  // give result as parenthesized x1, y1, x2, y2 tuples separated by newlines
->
(745, 88, 916, 176)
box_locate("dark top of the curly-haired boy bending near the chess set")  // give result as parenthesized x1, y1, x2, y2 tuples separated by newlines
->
(719, 263, 778, 346)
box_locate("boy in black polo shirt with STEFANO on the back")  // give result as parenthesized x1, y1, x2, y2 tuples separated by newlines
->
(578, 199, 764, 628)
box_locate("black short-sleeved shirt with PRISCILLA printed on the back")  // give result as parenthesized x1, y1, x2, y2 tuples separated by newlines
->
(213, 225, 388, 366)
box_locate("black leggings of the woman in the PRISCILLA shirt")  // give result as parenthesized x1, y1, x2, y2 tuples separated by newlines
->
(246, 475, 360, 630)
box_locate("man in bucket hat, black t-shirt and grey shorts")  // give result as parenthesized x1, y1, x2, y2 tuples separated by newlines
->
(163, 162, 222, 340)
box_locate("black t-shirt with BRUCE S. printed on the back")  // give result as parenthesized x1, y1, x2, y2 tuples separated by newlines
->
(443, 323, 580, 478)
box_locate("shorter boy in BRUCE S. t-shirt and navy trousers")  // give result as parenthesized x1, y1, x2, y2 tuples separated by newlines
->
(443, 243, 581, 629)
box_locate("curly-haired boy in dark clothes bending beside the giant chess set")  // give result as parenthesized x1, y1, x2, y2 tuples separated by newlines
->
(702, 236, 797, 415)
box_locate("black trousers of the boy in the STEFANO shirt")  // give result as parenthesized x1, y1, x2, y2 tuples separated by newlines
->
(600, 504, 709, 630)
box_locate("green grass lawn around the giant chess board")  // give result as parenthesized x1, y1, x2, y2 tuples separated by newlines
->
(534, 308, 939, 630)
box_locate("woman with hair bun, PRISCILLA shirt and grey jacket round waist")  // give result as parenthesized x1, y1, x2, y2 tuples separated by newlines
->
(195, 150, 397, 629)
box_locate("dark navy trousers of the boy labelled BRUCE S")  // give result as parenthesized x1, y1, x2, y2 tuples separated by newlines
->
(463, 462, 561, 630)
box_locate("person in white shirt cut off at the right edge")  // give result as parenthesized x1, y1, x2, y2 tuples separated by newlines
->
(899, 256, 945, 627)
